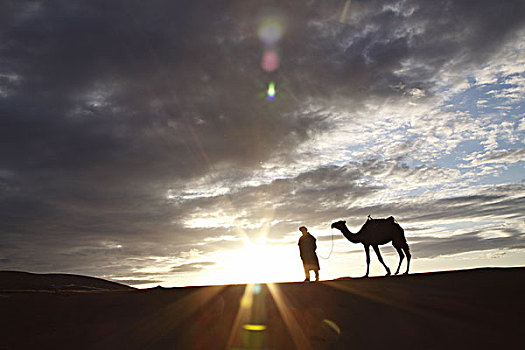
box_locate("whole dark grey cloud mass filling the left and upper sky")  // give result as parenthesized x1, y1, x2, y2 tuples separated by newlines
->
(0, 0, 525, 275)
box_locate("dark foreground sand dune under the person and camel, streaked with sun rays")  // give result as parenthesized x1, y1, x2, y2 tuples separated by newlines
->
(0, 268, 525, 349)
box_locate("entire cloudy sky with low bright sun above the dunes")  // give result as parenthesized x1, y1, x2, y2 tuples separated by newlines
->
(0, 0, 525, 288)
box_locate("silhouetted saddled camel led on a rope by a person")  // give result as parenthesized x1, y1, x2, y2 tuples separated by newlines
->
(332, 216, 412, 277)
